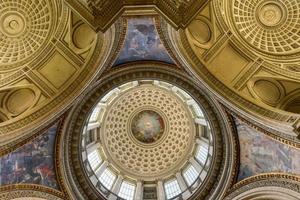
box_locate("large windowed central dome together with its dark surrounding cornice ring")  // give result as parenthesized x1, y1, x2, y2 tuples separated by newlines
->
(64, 63, 236, 200)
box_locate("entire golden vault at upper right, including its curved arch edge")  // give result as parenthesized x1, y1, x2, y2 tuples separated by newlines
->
(164, 0, 300, 138)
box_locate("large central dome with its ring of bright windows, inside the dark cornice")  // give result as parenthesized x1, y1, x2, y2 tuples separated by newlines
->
(82, 80, 213, 200)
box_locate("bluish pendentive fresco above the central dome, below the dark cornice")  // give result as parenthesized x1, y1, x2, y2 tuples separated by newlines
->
(114, 17, 173, 66)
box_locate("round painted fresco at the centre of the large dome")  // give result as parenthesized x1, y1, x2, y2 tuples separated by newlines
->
(131, 110, 165, 143)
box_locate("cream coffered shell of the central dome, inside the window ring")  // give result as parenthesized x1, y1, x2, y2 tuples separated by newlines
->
(100, 81, 196, 180)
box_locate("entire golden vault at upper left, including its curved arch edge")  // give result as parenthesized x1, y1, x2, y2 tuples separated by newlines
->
(0, 0, 114, 147)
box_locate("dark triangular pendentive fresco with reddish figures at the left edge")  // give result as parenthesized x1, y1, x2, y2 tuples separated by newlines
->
(0, 124, 58, 189)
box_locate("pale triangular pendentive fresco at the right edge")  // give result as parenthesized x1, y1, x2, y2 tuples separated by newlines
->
(235, 119, 300, 180)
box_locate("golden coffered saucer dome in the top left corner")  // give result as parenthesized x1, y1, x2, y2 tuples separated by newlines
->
(0, 0, 57, 66)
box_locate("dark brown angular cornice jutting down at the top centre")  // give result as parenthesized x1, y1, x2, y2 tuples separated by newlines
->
(65, 0, 208, 32)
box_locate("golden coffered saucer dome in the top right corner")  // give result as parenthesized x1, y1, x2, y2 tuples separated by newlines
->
(228, 0, 300, 58)
